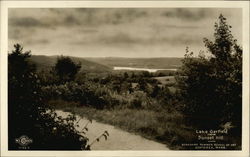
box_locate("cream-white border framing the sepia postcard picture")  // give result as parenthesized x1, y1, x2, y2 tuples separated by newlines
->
(0, 1, 250, 157)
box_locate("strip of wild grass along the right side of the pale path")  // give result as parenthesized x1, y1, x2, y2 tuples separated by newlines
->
(52, 102, 195, 150)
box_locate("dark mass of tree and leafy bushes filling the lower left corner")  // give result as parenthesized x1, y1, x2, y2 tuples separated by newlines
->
(8, 44, 87, 150)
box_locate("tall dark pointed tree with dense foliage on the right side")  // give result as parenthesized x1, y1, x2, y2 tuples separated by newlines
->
(177, 15, 242, 128)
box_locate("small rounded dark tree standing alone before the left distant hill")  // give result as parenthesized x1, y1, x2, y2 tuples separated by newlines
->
(55, 56, 81, 81)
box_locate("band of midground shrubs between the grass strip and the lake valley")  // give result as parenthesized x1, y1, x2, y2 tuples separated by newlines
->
(42, 75, 174, 109)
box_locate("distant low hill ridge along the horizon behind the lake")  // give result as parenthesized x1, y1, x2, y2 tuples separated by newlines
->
(31, 55, 183, 72)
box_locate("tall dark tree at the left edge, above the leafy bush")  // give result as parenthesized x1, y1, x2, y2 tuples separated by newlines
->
(8, 44, 42, 148)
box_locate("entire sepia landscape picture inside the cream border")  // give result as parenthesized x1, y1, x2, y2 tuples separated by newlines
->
(1, 0, 249, 156)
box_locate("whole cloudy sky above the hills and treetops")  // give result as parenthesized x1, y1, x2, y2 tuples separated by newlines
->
(8, 8, 242, 58)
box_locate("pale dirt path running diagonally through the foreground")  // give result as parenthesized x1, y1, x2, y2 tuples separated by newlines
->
(56, 110, 169, 150)
